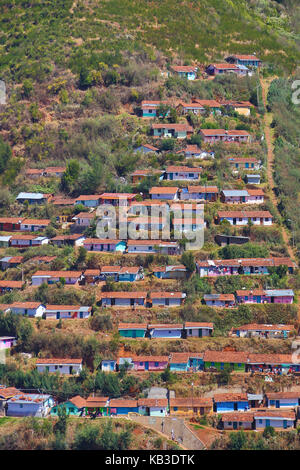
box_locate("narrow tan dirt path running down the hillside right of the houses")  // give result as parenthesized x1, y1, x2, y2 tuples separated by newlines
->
(260, 79, 295, 260)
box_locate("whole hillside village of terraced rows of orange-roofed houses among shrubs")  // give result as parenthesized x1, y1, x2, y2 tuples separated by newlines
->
(0, 2, 300, 449)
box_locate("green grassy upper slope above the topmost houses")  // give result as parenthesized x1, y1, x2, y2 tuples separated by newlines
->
(0, 0, 300, 82)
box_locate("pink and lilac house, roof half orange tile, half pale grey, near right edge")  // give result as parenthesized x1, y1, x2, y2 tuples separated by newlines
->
(236, 289, 294, 304)
